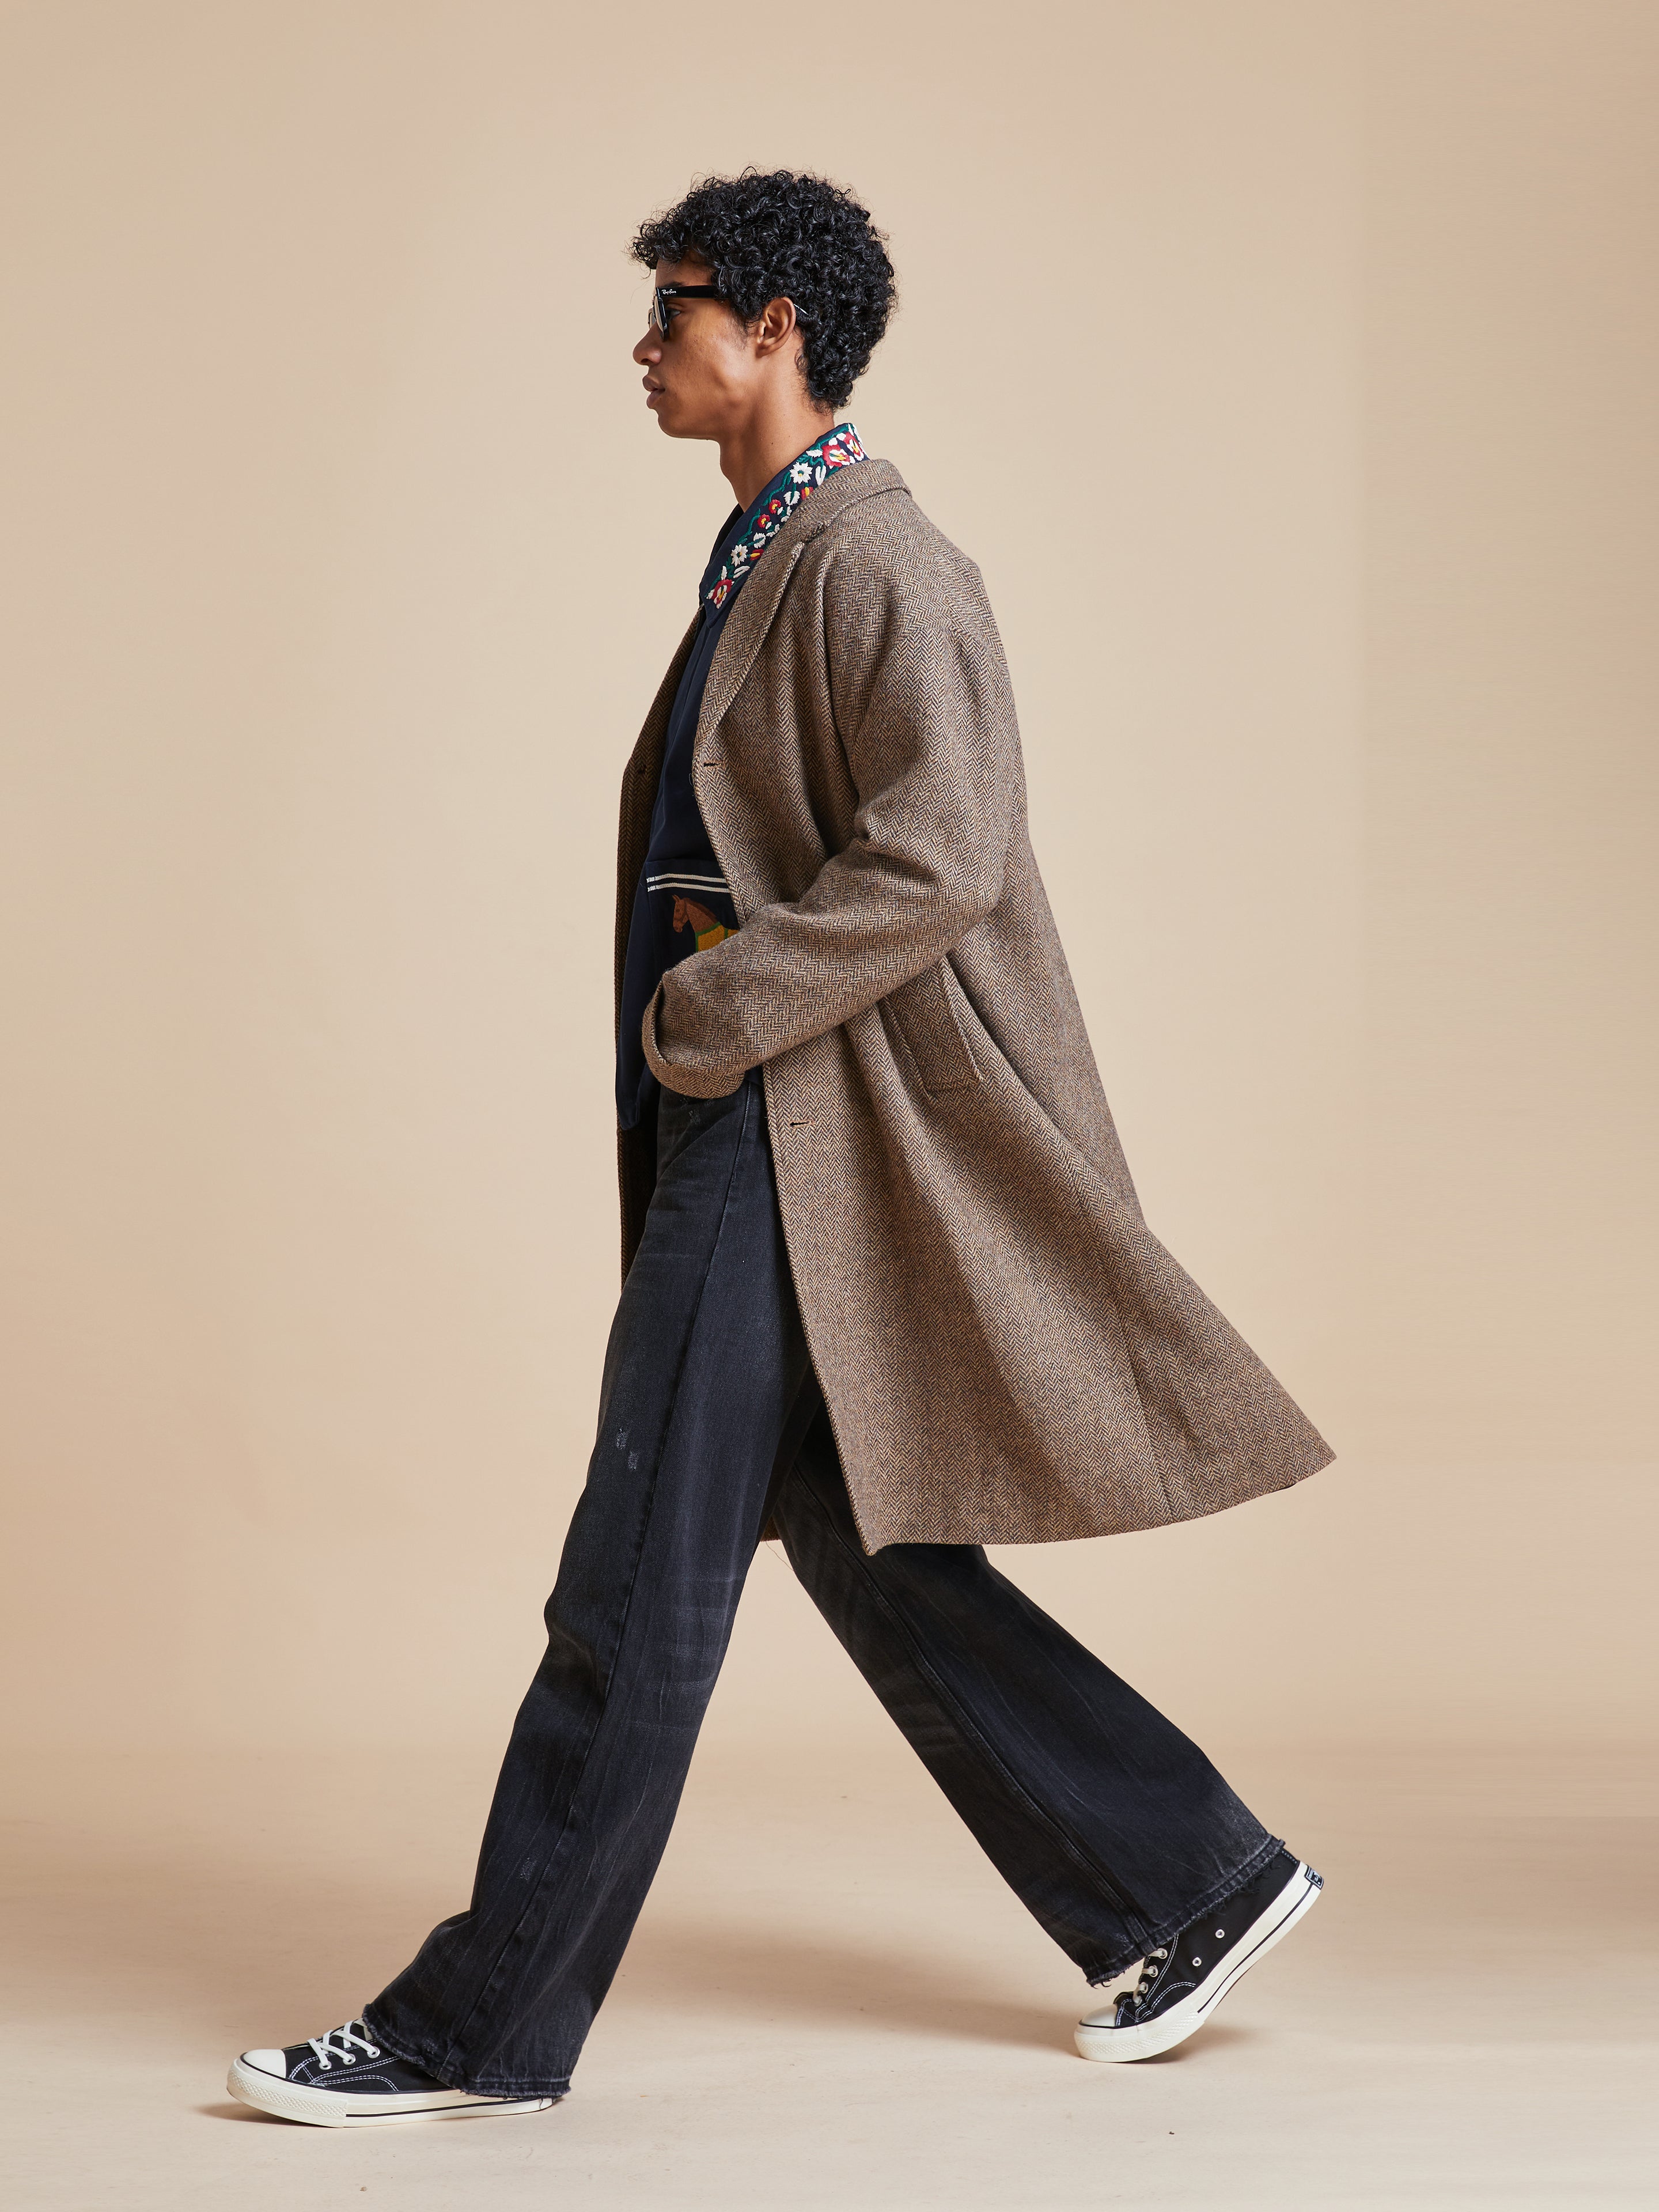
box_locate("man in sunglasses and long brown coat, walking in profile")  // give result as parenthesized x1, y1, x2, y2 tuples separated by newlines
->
(230, 171, 1332, 2126)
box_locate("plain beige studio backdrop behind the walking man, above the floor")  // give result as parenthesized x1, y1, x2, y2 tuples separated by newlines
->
(0, 0, 1659, 1749)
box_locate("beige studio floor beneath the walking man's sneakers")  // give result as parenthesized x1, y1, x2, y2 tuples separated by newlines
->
(5, 1577, 1659, 2212)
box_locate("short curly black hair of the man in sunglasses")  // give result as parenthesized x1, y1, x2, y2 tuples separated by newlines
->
(628, 168, 893, 407)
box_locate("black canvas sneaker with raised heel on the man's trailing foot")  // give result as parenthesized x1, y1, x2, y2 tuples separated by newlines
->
(1077, 1851, 1325, 2059)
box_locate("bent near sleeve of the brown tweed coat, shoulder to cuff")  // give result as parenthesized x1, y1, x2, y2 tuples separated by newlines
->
(642, 548, 1020, 1097)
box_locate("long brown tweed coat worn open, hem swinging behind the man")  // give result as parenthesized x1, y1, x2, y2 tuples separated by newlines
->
(617, 460, 1332, 1551)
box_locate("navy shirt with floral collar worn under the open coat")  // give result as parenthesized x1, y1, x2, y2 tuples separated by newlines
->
(617, 422, 865, 1128)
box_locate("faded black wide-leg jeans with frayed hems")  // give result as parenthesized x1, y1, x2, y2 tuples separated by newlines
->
(367, 1071, 1279, 2094)
